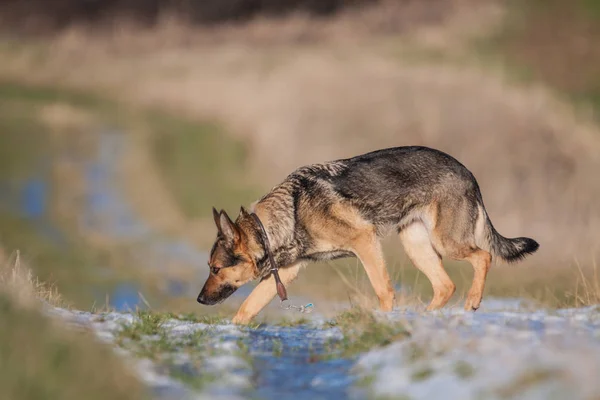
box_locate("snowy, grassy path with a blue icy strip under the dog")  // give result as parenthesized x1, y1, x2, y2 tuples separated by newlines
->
(47, 299, 600, 400)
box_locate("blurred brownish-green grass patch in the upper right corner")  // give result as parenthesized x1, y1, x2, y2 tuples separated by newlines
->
(485, 0, 600, 118)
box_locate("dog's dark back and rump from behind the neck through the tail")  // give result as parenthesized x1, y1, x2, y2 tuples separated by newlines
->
(286, 146, 537, 261)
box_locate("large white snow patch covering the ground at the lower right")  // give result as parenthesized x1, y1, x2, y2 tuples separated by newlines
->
(354, 301, 600, 400)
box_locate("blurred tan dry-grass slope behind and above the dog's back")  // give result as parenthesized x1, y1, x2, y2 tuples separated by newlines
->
(0, 0, 600, 260)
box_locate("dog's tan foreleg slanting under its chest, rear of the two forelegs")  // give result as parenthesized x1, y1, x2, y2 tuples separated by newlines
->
(352, 232, 395, 311)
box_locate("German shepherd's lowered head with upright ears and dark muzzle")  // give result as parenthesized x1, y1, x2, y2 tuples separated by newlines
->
(198, 207, 258, 305)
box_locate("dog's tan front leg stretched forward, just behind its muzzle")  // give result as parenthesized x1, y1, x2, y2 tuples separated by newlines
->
(232, 263, 302, 325)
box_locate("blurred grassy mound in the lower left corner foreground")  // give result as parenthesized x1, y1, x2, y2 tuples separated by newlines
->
(0, 248, 143, 400)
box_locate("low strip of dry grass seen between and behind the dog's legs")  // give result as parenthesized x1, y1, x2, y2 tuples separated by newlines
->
(292, 244, 600, 316)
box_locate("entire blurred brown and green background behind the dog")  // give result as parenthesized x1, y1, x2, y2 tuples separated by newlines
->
(0, 0, 600, 313)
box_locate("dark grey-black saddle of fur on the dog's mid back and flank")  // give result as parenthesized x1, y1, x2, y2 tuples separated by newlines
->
(331, 147, 479, 228)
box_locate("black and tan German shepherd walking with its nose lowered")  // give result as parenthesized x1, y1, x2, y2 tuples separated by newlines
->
(198, 146, 539, 324)
